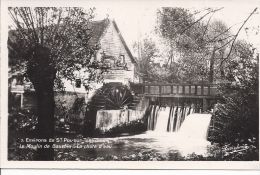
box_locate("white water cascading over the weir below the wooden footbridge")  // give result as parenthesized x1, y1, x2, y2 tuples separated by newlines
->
(145, 106, 211, 155)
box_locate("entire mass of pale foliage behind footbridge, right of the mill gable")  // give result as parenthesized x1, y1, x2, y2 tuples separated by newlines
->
(138, 7, 255, 83)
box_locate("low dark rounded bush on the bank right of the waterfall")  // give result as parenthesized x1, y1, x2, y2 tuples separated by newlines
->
(209, 91, 259, 144)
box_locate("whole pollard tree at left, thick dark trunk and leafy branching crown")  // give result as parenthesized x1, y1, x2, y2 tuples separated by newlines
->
(8, 7, 106, 160)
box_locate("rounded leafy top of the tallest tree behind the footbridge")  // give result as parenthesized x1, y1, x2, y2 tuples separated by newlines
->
(157, 7, 210, 51)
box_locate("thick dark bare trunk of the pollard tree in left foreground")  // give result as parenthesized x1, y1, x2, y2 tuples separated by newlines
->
(27, 46, 56, 160)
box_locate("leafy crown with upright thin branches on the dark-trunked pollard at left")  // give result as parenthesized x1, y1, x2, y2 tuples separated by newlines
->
(8, 7, 107, 88)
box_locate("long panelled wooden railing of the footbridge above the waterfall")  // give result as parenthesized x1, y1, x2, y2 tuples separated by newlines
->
(131, 83, 217, 96)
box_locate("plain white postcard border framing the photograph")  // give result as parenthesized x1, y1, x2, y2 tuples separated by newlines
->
(0, 0, 260, 169)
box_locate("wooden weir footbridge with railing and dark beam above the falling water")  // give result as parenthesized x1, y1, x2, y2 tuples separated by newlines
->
(130, 82, 220, 112)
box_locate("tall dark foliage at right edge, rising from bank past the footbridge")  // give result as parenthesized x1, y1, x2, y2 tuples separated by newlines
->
(209, 40, 259, 144)
